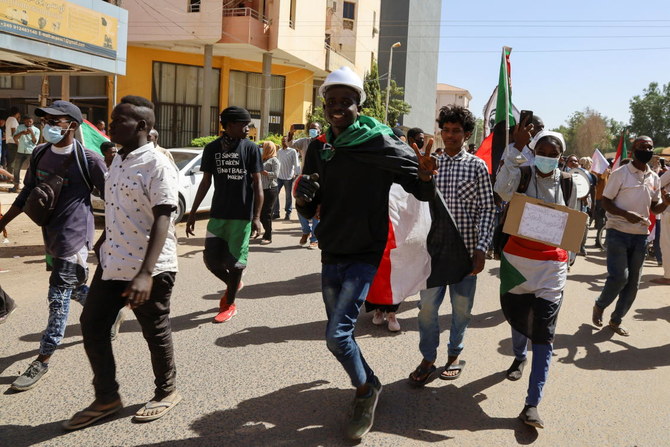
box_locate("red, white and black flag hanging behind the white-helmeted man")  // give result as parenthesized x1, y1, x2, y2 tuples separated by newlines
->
(366, 184, 472, 304)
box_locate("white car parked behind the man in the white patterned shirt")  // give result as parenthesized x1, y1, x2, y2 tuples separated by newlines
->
(91, 148, 214, 222)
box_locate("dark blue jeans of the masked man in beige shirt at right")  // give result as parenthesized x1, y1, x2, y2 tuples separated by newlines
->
(596, 228, 647, 324)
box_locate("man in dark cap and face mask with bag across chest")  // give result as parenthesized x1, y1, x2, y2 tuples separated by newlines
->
(0, 101, 107, 391)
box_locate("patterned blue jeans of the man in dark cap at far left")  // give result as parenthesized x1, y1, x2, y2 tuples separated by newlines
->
(40, 258, 88, 355)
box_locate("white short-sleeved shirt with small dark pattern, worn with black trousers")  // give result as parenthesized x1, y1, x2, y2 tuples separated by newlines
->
(100, 143, 179, 281)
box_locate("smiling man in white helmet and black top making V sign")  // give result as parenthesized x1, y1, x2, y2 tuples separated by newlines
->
(294, 67, 436, 439)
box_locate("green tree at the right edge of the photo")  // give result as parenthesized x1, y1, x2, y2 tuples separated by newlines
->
(630, 82, 670, 146)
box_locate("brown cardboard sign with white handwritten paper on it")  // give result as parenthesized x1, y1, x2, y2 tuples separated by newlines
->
(503, 193, 588, 252)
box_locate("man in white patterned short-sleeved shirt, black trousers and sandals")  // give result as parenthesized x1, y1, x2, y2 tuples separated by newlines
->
(63, 96, 181, 430)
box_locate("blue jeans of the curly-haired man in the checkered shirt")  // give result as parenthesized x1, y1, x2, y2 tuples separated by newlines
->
(418, 276, 477, 362)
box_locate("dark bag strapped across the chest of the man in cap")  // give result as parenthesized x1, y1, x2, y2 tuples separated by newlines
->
(23, 140, 93, 227)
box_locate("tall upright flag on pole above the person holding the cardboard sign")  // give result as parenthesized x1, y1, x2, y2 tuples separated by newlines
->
(491, 47, 516, 178)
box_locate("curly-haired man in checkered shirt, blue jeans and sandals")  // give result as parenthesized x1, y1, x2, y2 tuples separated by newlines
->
(410, 106, 496, 385)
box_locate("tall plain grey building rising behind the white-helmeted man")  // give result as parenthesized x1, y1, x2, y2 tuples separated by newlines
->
(379, 0, 442, 133)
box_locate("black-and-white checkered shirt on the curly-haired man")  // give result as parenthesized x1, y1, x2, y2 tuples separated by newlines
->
(435, 150, 496, 254)
